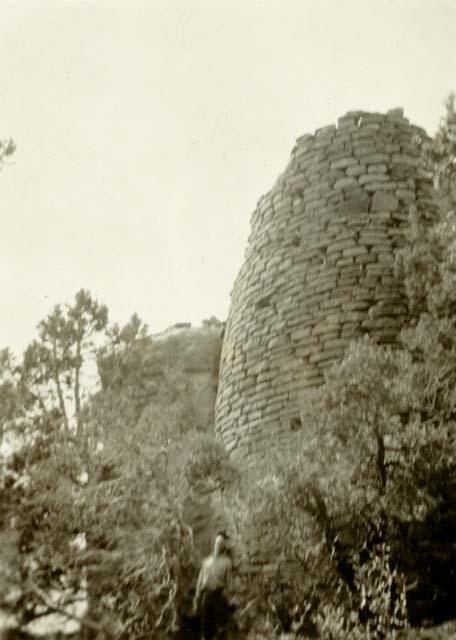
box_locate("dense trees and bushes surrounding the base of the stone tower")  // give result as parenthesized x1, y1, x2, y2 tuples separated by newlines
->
(0, 98, 456, 639)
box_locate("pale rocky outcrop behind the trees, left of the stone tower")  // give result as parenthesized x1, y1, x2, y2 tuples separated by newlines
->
(97, 318, 224, 431)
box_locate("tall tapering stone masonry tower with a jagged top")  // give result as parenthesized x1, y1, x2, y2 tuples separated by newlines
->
(216, 109, 433, 458)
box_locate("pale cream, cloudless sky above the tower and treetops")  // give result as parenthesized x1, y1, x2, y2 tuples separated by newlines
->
(0, 0, 456, 354)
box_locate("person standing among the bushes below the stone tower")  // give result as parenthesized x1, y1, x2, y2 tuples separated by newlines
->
(194, 532, 233, 640)
